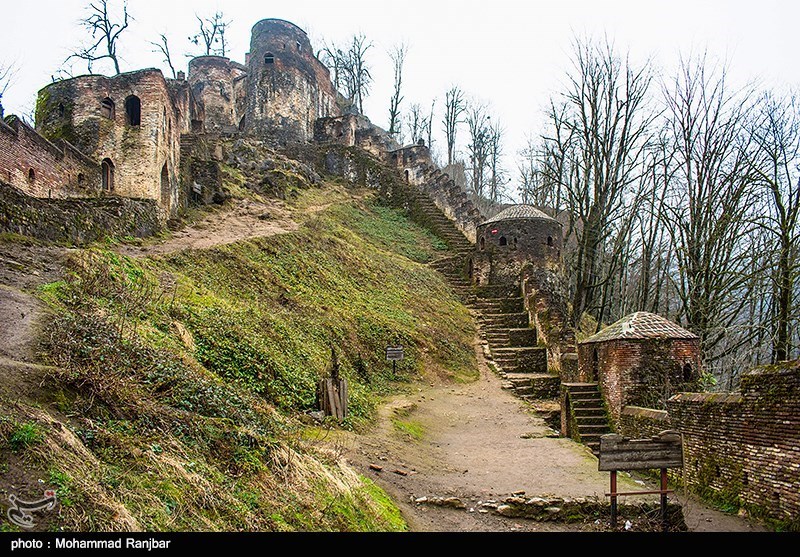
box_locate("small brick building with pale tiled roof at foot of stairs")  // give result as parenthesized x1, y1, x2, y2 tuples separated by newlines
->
(578, 311, 700, 425)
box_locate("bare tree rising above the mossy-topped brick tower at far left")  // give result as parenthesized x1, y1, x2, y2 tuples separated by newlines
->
(67, 0, 133, 74)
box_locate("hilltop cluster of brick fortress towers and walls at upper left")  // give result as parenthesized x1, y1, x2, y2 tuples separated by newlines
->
(0, 19, 346, 219)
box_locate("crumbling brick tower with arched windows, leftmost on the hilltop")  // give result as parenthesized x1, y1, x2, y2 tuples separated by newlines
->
(36, 69, 184, 214)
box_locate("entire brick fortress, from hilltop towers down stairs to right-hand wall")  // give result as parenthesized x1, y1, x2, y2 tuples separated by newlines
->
(0, 14, 800, 524)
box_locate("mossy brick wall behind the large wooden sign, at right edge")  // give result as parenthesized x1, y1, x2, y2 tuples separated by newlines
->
(668, 362, 800, 527)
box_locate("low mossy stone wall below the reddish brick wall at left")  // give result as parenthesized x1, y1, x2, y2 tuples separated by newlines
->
(0, 182, 162, 245)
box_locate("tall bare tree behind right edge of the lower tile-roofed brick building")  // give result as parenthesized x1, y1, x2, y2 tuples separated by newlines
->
(663, 57, 755, 372)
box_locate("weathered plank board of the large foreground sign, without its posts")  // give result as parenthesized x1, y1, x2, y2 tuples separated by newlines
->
(598, 431, 683, 471)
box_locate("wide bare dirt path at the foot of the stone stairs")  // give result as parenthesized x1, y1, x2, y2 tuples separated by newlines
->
(346, 334, 763, 531)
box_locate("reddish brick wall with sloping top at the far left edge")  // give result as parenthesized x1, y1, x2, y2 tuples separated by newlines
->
(0, 116, 100, 198)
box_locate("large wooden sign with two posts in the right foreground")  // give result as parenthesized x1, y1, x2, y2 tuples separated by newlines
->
(598, 430, 683, 530)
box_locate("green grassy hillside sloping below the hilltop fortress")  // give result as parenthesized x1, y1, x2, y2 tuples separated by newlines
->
(0, 186, 475, 530)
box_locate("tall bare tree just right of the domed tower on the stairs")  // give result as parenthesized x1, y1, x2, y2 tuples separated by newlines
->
(543, 34, 654, 326)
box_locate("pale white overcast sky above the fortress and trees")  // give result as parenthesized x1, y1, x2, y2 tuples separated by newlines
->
(0, 0, 800, 198)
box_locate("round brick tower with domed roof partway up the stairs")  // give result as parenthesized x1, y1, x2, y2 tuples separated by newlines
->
(470, 205, 562, 285)
